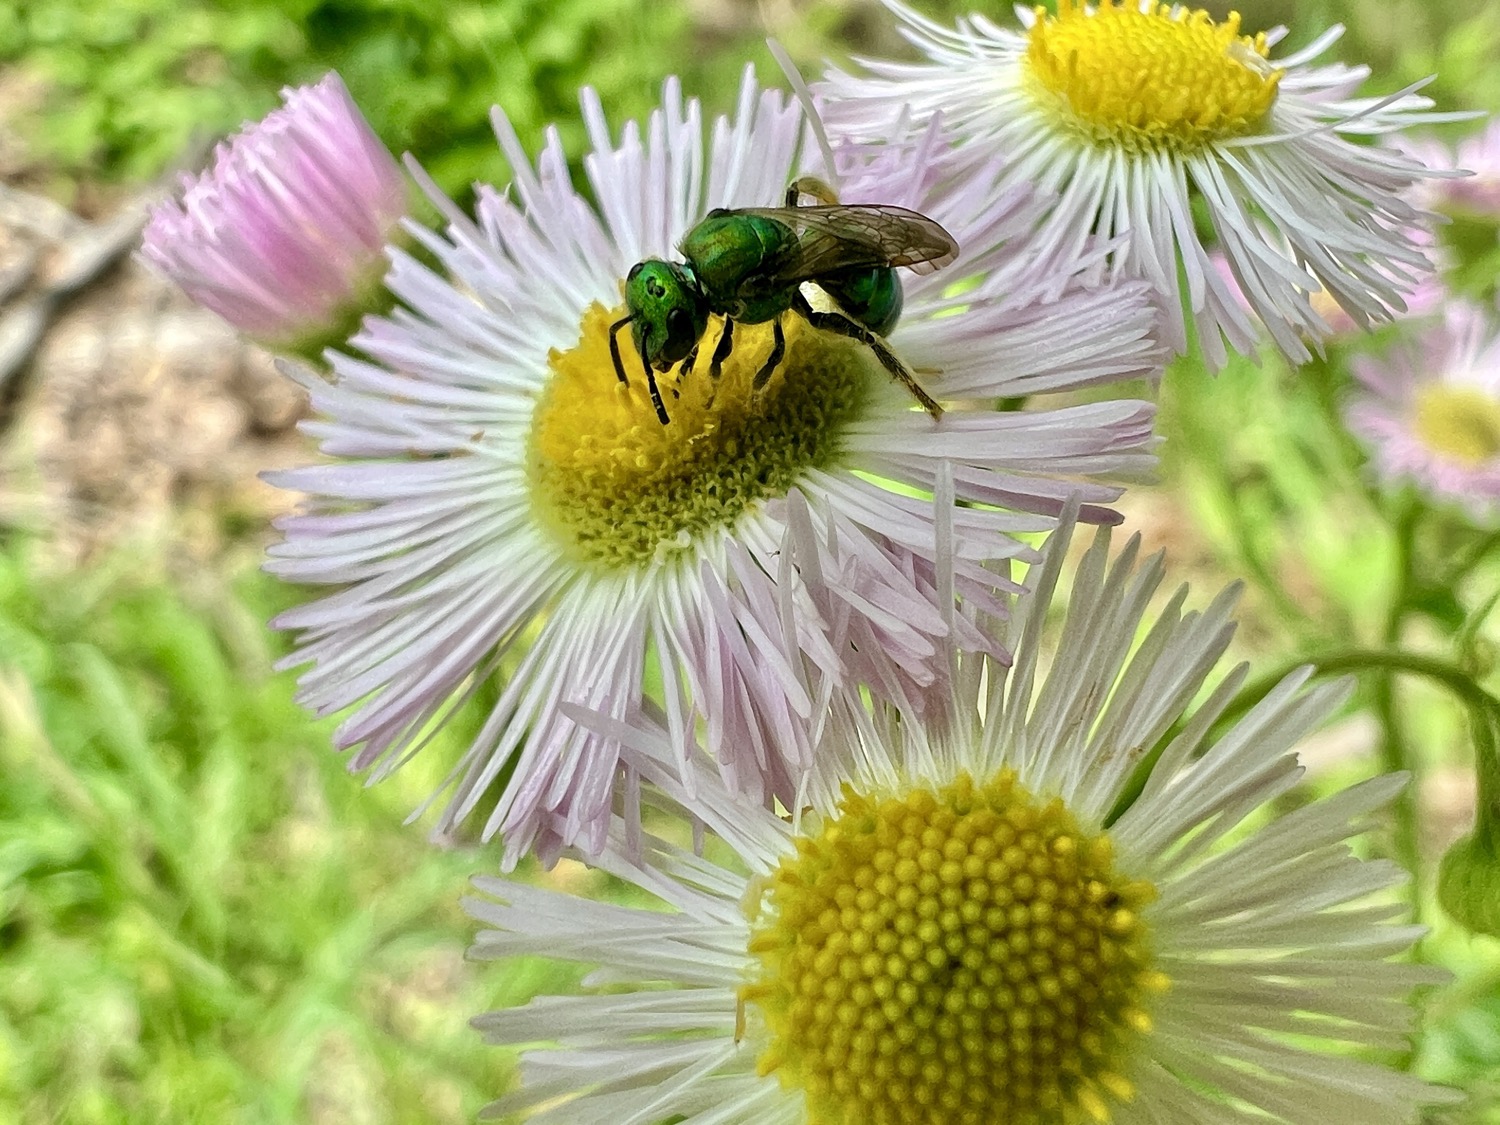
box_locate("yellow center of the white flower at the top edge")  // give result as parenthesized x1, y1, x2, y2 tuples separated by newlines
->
(1026, 0, 1283, 153)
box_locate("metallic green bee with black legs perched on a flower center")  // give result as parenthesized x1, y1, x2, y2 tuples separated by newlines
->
(609, 179, 959, 426)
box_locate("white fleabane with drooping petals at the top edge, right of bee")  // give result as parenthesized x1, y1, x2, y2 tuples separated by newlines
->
(816, 0, 1437, 366)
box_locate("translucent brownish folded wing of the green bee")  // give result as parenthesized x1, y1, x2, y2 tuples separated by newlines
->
(735, 204, 959, 282)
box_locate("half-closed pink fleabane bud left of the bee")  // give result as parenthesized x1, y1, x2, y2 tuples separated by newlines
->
(141, 72, 407, 354)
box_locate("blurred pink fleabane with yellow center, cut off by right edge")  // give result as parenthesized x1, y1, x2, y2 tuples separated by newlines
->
(1346, 299, 1500, 522)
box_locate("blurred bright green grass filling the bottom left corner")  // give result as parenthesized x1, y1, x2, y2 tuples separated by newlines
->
(0, 543, 569, 1125)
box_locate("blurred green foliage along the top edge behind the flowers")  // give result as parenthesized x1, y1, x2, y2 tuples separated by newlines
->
(0, 0, 1500, 198)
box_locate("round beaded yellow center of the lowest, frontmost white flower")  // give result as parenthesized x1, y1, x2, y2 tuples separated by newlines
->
(741, 770, 1169, 1125)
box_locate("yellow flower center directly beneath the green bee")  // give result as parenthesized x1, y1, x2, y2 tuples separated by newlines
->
(528, 303, 879, 569)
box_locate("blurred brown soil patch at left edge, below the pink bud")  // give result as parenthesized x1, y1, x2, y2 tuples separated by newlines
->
(0, 208, 311, 561)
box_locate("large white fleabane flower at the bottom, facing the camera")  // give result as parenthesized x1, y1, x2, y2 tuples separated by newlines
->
(465, 519, 1446, 1125)
